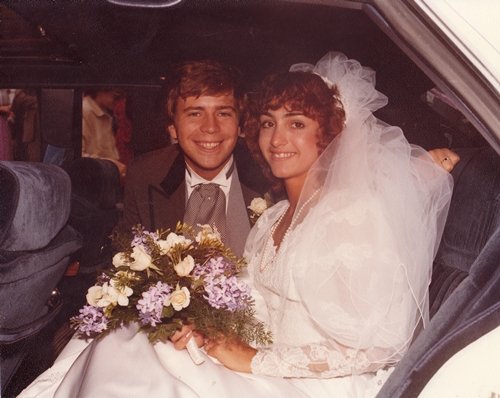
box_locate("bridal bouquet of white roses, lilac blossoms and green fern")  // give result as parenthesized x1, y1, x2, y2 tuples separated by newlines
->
(71, 223, 271, 362)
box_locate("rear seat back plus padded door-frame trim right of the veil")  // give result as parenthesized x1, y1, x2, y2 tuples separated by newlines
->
(377, 148, 500, 398)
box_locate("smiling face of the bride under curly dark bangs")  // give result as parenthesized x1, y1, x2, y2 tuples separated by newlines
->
(259, 107, 321, 184)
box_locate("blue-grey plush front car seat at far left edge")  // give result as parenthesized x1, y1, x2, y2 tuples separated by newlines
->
(0, 162, 82, 392)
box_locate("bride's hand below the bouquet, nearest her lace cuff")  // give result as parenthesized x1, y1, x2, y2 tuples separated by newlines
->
(204, 336, 257, 373)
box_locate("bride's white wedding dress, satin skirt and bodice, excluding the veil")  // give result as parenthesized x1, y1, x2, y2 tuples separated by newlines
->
(14, 202, 398, 398)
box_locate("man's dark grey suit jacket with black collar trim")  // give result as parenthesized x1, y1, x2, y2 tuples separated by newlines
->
(118, 139, 269, 254)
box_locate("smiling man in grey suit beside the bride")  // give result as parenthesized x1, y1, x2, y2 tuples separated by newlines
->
(118, 60, 269, 255)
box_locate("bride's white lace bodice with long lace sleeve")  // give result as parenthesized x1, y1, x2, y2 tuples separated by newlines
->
(249, 202, 406, 378)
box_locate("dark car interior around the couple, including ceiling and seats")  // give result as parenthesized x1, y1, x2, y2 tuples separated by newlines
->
(0, 0, 500, 397)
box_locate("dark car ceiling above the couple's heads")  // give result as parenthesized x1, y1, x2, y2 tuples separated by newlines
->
(3, 0, 430, 96)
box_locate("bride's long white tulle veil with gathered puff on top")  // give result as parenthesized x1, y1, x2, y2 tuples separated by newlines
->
(246, 52, 452, 390)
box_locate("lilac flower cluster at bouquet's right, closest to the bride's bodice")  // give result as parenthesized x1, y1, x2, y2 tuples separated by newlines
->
(193, 257, 252, 312)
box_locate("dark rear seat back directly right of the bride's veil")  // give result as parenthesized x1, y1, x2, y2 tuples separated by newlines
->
(430, 148, 500, 318)
